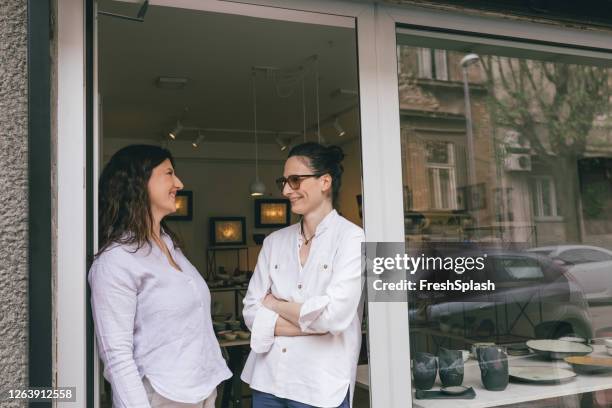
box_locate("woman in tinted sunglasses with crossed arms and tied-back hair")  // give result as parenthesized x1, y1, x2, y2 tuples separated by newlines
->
(241, 143, 364, 408)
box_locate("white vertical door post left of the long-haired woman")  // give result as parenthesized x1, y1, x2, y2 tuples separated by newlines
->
(54, 0, 88, 407)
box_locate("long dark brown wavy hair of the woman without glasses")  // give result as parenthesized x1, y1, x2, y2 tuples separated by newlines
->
(95, 145, 182, 257)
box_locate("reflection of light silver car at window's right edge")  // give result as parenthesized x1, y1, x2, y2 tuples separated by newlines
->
(529, 245, 612, 302)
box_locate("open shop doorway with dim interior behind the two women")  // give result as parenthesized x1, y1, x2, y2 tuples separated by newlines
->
(94, 0, 369, 407)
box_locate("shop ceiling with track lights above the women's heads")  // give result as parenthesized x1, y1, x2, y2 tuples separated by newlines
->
(98, 0, 358, 143)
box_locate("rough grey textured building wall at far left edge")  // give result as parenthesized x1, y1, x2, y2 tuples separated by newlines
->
(0, 0, 28, 400)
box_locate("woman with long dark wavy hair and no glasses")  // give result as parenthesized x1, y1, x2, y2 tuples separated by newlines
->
(89, 145, 232, 408)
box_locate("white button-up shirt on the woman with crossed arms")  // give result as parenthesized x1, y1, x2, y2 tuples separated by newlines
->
(241, 210, 364, 407)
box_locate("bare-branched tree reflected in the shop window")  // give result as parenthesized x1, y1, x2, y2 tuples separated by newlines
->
(481, 56, 610, 242)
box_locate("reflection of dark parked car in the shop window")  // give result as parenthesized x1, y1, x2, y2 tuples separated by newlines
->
(410, 250, 593, 344)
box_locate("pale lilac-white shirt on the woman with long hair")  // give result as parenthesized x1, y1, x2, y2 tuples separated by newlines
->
(89, 229, 232, 408)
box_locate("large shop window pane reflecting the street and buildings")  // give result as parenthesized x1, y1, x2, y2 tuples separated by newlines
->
(397, 28, 612, 406)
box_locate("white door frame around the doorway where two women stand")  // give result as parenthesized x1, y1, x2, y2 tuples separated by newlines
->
(56, 0, 411, 408)
